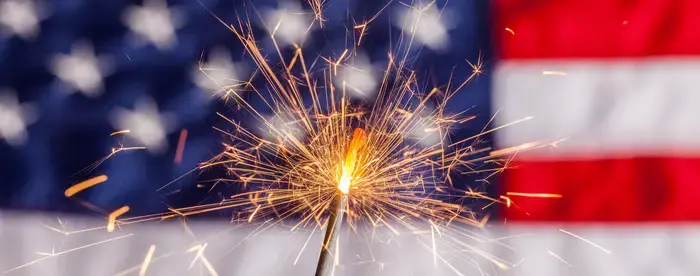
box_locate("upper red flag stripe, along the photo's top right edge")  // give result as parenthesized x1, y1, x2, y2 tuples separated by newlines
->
(494, 0, 700, 59)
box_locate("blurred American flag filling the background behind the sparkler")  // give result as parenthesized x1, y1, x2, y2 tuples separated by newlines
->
(0, 0, 700, 275)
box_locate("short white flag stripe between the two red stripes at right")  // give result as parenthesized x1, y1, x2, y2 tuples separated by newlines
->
(492, 58, 700, 158)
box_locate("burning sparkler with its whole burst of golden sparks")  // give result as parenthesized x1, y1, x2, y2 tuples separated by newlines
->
(49, 1, 542, 275)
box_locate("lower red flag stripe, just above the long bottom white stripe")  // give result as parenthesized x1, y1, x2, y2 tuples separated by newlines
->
(503, 157, 700, 222)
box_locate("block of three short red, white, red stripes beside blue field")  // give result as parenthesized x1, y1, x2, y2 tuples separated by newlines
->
(493, 0, 700, 222)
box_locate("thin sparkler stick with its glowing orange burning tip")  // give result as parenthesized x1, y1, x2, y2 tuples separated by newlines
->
(316, 128, 367, 276)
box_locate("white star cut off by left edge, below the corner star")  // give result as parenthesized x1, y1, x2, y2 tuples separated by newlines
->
(0, 90, 37, 146)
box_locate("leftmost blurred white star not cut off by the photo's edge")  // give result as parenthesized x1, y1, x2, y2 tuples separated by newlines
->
(50, 42, 111, 97)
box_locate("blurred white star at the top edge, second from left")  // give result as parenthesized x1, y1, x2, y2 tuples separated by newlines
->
(123, 0, 185, 50)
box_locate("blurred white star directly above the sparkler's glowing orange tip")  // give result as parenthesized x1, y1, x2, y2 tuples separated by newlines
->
(334, 52, 378, 98)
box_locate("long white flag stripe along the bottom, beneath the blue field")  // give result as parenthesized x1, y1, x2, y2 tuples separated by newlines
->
(0, 213, 700, 276)
